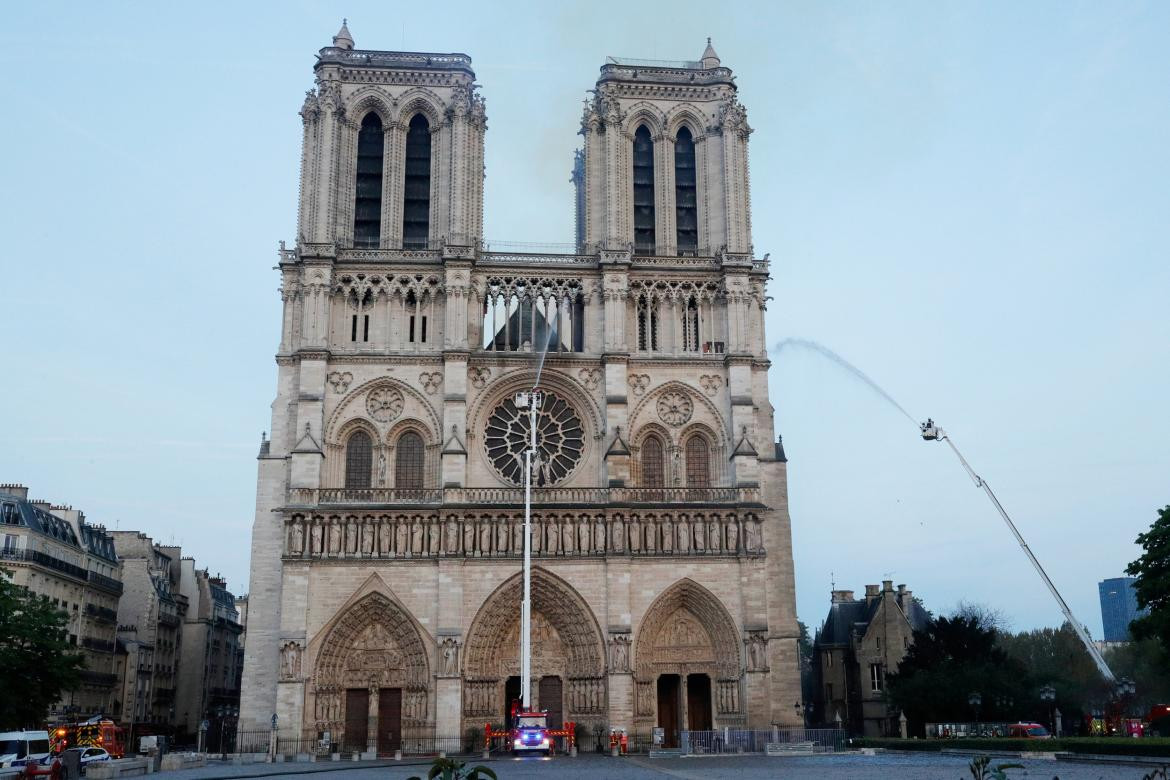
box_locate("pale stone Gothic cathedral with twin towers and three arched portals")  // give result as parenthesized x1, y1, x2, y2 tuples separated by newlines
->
(240, 26, 803, 752)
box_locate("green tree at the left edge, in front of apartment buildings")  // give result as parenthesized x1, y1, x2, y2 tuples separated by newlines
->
(0, 570, 82, 729)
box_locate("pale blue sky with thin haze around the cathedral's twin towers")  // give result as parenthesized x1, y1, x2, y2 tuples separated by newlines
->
(0, 0, 1170, 636)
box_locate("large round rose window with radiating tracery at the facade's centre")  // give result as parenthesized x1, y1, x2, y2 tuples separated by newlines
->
(483, 392, 585, 486)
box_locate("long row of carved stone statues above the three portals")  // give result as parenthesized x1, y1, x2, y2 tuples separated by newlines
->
(285, 512, 764, 558)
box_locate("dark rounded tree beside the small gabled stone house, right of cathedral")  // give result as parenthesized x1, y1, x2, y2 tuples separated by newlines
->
(886, 615, 1032, 734)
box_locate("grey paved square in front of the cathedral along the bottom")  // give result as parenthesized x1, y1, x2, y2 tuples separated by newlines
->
(163, 753, 1170, 780)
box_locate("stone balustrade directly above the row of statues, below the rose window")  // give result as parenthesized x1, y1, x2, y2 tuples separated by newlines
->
(289, 488, 762, 506)
